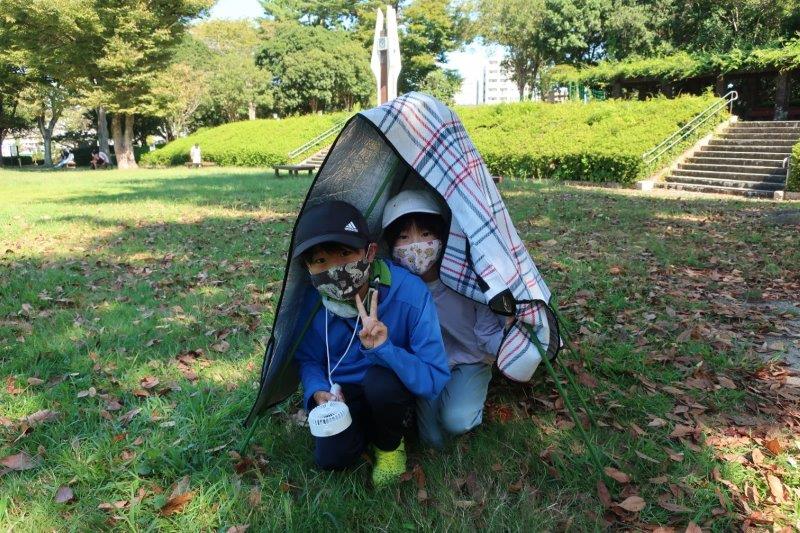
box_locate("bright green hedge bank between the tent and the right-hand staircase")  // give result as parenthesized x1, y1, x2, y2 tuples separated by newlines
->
(458, 95, 727, 183)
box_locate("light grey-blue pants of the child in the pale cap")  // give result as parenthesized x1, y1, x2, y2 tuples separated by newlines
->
(417, 363, 492, 448)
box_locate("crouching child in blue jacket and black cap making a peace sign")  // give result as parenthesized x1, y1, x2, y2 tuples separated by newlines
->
(293, 201, 450, 487)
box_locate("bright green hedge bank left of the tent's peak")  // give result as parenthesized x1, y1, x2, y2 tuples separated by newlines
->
(141, 113, 350, 167)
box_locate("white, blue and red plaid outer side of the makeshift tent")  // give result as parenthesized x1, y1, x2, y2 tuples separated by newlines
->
(361, 93, 560, 381)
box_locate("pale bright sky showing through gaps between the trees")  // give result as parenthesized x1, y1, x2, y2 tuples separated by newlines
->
(206, 0, 500, 104)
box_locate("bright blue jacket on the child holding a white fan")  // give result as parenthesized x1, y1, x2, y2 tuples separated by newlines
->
(295, 261, 450, 409)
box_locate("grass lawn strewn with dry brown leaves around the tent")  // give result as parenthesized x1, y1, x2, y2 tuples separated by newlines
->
(0, 168, 800, 531)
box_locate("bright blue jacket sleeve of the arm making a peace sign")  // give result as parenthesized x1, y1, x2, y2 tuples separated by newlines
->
(362, 289, 450, 399)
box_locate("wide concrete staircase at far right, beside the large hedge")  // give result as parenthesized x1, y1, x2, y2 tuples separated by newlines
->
(659, 121, 800, 198)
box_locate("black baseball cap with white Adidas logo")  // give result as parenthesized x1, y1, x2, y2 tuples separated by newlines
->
(292, 200, 370, 259)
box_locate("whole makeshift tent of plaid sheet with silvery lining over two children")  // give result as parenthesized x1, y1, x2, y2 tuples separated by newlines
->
(245, 93, 561, 425)
